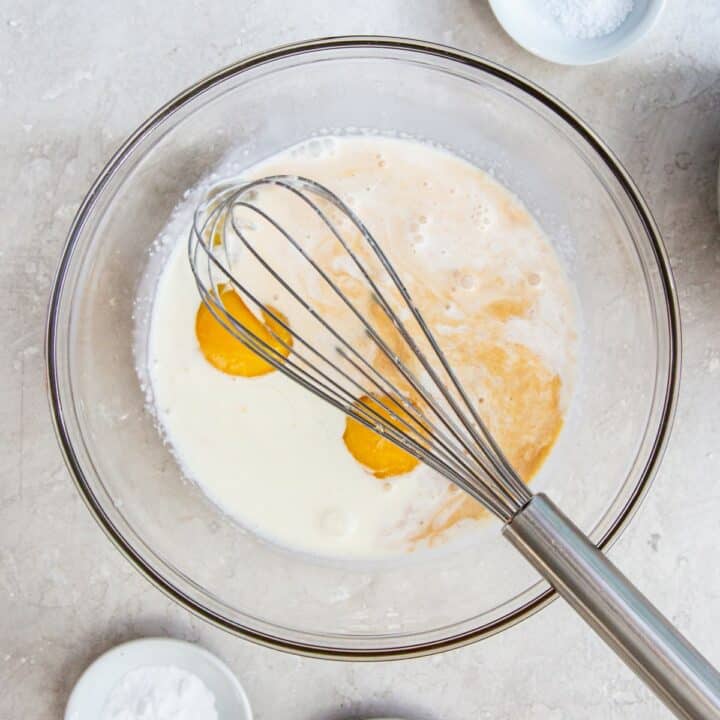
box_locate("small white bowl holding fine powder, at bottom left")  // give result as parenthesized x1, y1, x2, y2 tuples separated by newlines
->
(65, 638, 252, 720)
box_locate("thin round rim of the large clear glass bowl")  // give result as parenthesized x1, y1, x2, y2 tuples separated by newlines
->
(45, 35, 681, 661)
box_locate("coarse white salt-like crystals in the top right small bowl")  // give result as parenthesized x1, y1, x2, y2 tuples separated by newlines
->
(543, 0, 634, 40)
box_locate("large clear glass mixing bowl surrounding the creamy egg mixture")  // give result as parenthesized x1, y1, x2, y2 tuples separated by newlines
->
(47, 38, 679, 659)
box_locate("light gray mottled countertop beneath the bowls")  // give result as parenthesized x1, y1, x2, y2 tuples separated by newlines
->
(0, 0, 720, 720)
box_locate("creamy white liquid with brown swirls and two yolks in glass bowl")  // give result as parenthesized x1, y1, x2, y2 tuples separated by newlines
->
(147, 135, 576, 557)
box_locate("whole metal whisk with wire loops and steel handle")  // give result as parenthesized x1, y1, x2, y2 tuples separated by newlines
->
(188, 175, 720, 720)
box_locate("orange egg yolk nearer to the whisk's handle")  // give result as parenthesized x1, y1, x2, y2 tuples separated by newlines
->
(343, 395, 420, 478)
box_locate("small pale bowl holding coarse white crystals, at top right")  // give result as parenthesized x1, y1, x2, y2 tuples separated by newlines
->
(490, 0, 665, 65)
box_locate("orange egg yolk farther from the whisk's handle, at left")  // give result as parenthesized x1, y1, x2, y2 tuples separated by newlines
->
(195, 287, 292, 377)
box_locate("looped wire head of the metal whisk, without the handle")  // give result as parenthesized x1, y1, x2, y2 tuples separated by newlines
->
(188, 175, 532, 521)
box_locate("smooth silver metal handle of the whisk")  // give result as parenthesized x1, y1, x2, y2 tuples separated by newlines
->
(503, 494, 720, 720)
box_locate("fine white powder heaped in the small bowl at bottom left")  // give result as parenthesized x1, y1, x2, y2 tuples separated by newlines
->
(102, 666, 218, 720)
